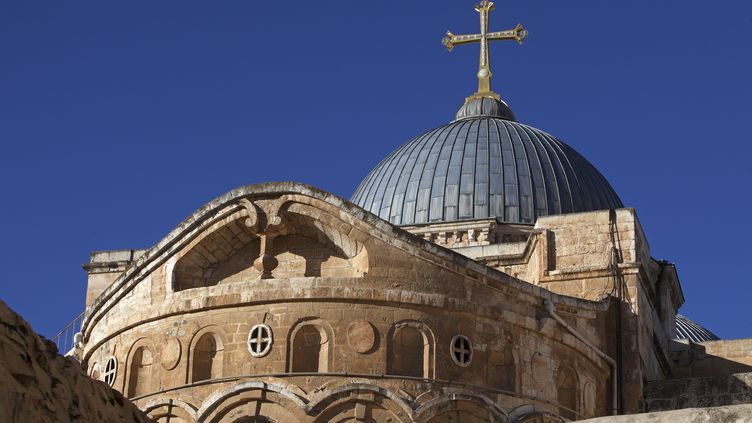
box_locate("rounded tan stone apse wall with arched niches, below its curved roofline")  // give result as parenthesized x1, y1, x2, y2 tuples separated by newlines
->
(82, 186, 610, 422)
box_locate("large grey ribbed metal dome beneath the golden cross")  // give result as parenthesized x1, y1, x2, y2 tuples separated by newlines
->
(352, 116, 622, 225)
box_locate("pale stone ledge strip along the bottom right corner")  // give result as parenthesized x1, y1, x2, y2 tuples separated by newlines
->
(582, 404, 752, 423)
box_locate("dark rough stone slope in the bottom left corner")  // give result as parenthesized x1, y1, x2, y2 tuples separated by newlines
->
(0, 301, 150, 423)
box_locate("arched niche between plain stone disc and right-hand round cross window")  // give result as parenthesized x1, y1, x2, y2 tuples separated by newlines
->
(387, 323, 433, 378)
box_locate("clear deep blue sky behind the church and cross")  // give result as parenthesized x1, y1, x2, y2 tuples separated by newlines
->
(0, 0, 752, 338)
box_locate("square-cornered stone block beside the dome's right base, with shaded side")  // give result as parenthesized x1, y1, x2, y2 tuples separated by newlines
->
(468, 209, 680, 412)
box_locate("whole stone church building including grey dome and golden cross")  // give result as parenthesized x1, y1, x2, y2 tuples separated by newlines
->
(73, 0, 752, 423)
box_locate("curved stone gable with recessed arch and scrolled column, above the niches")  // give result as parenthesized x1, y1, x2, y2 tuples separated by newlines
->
(82, 183, 608, 349)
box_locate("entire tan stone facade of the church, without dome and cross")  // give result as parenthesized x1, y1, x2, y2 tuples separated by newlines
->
(72, 183, 746, 423)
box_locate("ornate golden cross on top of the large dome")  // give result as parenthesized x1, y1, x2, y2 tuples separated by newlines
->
(441, 0, 527, 100)
